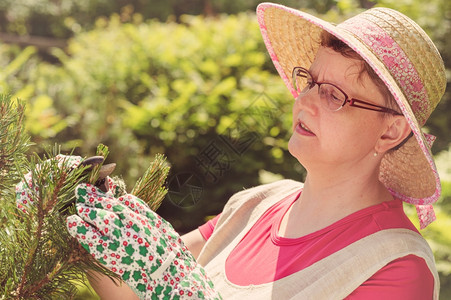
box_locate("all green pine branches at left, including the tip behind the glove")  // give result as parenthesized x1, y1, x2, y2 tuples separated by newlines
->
(0, 96, 169, 299)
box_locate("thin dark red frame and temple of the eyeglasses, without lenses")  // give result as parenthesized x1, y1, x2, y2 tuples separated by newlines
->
(291, 67, 402, 115)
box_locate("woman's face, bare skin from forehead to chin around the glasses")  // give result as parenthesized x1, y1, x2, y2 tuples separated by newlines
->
(288, 47, 387, 171)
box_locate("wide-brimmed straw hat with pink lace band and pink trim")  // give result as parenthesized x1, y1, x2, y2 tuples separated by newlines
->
(257, 3, 446, 228)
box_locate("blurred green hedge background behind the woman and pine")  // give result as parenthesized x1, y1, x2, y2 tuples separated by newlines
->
(0, 0, 451, 299)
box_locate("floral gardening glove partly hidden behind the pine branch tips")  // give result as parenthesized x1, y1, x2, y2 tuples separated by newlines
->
(16, 154, 119, 211)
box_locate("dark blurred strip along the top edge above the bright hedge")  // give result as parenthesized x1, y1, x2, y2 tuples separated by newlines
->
(0, 0, 335, 38)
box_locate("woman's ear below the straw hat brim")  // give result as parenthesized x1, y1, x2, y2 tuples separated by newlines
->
(375, 116, 412, 153)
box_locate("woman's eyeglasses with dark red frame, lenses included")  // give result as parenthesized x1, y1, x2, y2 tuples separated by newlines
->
(292, 67, 401, 115)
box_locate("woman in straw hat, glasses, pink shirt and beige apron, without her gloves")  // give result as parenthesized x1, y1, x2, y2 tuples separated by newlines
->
(65, 3, 446, 299)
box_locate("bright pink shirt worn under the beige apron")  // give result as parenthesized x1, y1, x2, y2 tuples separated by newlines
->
(199, 192, 434, 300)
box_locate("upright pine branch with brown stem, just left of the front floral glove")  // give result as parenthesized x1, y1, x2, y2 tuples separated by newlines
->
(15, 148, 90, 299)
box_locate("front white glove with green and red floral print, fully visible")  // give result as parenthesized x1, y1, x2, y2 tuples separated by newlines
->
(67, 184, 221, 299)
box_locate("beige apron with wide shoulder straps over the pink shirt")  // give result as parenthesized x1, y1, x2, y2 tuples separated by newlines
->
(198, 180, 440, 300)
